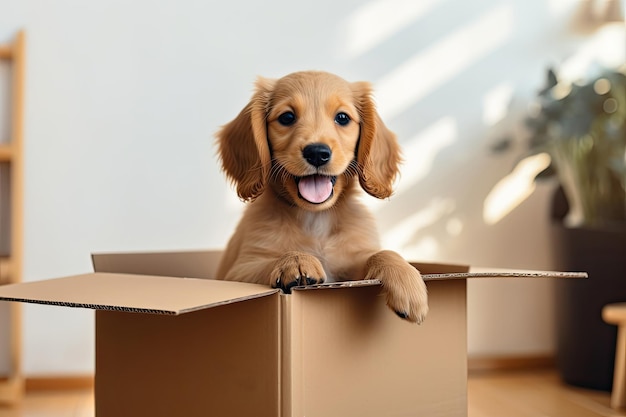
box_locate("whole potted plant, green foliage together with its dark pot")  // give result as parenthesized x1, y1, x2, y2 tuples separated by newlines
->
(508, 65, 626, 390)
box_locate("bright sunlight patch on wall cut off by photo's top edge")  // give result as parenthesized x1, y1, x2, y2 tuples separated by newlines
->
(345, 0, 442, 59)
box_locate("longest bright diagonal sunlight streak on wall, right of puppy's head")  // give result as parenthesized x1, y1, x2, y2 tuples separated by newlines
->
(376, 5, 514, 120)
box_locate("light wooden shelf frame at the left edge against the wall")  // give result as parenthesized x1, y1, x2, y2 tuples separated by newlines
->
(0, 31, 25, 404)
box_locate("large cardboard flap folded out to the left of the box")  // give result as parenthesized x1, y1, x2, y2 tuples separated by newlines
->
(0, 273, 279, 315)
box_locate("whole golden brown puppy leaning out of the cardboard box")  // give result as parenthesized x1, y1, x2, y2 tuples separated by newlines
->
(217, 71, 428, 323)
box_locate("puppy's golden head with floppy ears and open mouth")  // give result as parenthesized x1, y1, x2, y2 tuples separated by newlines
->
(217, 71, 400, 211)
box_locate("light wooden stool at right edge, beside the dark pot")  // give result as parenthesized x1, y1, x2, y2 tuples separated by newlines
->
(602, 303, 626, 409)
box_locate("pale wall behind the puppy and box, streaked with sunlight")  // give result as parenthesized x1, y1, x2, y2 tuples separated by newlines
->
(0, 0, 620, 375)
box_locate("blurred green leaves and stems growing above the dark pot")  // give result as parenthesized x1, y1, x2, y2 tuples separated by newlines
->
(526, 65, 626, 228)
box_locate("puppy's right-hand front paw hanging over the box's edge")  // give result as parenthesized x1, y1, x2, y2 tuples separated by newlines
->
(365, 251, 428, 324)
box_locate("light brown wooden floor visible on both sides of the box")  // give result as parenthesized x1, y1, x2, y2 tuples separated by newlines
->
(0, 370, 626, 417)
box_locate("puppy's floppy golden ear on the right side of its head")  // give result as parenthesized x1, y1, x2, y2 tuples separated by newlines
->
(352, 82, 401, 198)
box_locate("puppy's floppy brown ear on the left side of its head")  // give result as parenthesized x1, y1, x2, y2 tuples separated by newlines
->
(216, 77, 275, 201)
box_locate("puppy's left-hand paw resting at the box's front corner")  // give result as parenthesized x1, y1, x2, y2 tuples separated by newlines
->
(270, 251, 326, 294)
